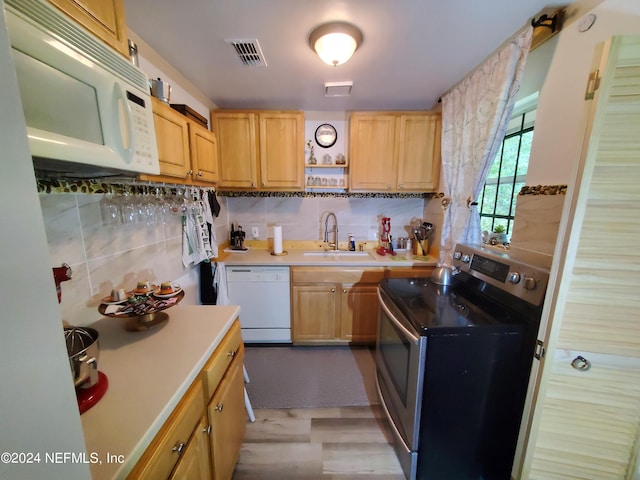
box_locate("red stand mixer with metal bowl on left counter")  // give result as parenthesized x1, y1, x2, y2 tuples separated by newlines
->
(53, 263, 109, 414)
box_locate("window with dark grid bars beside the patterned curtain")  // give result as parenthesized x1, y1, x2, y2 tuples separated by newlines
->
(478, 94, 537, 235)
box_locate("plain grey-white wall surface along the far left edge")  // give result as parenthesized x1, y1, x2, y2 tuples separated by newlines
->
(0, 0, 90, 480)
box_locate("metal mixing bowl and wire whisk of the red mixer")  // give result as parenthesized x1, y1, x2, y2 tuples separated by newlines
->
(64, 327, 100, 387)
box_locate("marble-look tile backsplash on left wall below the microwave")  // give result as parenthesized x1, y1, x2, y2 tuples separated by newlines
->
(40, 193, 226, 325)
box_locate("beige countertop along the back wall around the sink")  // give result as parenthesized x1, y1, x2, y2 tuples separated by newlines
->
(218, 248, 437, 267)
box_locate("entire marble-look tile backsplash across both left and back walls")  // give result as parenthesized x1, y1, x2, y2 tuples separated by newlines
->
(40, 193, 426, 325)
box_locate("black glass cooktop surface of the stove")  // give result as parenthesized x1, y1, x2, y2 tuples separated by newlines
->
(380, 278, 520, 334)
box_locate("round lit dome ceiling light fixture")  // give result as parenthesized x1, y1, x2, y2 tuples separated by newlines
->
(309, 22, 362, 67)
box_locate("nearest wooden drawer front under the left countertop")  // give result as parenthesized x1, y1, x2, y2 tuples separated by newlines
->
(128, 379, 205, 480)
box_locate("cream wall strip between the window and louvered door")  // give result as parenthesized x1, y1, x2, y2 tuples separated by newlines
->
(527, 0, 640, 185)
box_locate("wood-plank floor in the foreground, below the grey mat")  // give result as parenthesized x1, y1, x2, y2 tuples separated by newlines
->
(233, 406, 405, 480)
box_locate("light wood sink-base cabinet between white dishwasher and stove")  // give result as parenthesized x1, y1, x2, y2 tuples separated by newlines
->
(291, 267, 433, 344)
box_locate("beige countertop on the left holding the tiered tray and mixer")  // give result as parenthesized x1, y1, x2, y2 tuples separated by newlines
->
(81, 305, 240, 480)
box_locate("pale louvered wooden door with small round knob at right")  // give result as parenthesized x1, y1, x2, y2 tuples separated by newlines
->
(522, 37, 640, 480)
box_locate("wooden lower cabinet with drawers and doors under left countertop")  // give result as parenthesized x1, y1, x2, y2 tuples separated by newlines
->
(128, 320, 247, 480)
